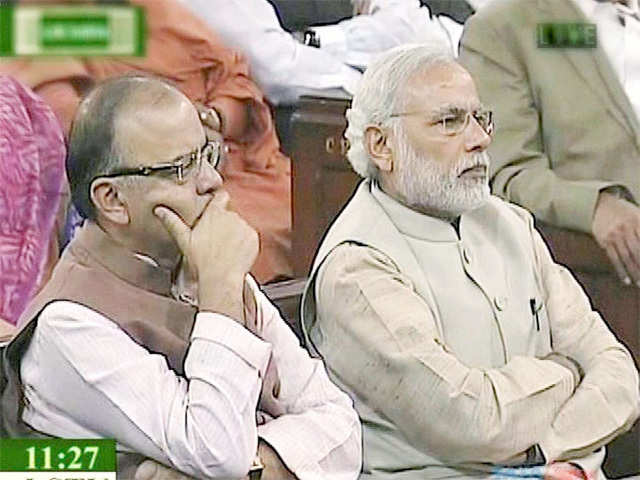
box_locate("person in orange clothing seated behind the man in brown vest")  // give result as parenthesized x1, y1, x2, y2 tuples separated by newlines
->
(0, 0, 293, 283)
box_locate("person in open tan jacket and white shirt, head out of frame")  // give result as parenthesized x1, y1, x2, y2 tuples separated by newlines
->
(460, 0, 640, 286)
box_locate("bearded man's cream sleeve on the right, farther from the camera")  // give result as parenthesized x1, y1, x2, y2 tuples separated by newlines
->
(533, 225, 640, 461)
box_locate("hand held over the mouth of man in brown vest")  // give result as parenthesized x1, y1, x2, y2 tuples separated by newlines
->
(154, 197, 258, 324)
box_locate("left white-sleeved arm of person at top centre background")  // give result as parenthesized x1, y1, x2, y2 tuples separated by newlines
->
(183, 0, 361, 104)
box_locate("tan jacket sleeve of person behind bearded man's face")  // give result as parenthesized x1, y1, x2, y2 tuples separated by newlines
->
(459, 5, 612, 233)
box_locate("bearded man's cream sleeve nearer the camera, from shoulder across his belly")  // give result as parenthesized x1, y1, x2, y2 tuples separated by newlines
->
(316, 244, 575, 464)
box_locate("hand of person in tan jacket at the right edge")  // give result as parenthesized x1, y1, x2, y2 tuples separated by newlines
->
(592, 192, 640, 286)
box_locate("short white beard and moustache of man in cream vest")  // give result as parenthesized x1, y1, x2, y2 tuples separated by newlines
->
(396, 128, 490, 218)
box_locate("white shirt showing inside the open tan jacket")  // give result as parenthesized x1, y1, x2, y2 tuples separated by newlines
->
(574, 0, 640, 120)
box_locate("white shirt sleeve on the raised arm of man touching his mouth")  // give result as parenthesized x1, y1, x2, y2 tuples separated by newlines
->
(21, 301, 271, 478)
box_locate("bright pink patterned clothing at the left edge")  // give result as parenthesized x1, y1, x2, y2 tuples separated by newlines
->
(0, 76, 65, 324)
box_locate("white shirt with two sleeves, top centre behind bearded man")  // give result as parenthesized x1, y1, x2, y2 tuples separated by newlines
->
(182, 0, 459, 104)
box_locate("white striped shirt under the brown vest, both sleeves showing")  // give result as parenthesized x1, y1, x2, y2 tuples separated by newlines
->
(21, 280, 361, 480)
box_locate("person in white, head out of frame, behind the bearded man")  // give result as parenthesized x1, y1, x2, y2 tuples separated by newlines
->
(181, 0, 458, 105)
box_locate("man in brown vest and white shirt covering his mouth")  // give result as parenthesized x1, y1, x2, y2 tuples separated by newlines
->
(2, 77, 361, 480)
